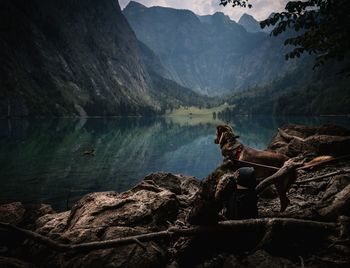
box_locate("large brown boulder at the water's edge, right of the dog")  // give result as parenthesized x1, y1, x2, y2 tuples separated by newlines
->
(268, 125, 350, 157)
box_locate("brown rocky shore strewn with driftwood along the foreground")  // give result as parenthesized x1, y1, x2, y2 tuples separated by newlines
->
(0, 125, 350, 268)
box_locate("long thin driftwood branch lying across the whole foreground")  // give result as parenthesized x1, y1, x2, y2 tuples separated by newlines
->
(0, 218, 339, 252)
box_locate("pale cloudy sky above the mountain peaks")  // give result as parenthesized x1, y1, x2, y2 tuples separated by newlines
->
(119, 0, 288, 21)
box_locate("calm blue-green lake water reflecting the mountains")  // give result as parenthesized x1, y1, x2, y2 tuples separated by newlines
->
(0, 114, 350, 210)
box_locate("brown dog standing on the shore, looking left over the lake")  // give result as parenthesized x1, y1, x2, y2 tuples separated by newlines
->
(214, 125, 290, 211)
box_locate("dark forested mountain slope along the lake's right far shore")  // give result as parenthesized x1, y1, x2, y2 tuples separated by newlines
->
(219, 61, 350, 116)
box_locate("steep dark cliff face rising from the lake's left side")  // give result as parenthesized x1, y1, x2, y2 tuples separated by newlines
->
(0, 0, 159, 116)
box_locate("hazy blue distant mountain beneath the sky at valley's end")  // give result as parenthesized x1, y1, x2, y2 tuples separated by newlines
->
(123, 1, 306, 95)
